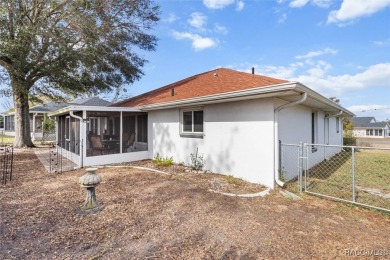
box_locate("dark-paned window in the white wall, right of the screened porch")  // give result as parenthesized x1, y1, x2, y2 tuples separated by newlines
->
(181, 109, 203, 135)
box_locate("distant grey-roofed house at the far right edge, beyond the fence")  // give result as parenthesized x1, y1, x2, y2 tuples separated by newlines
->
(349, 117, 390, 138)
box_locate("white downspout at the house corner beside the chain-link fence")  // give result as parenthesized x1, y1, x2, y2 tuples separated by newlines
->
(274, 92, 307, 187)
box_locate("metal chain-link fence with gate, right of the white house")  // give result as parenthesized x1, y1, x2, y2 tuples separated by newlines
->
(280, 144, 390, 212)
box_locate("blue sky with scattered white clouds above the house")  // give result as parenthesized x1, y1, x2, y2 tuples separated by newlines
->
(0, 0, 390, 120)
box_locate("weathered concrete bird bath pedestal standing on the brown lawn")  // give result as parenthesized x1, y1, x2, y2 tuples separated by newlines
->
(77, 168, 103, 214)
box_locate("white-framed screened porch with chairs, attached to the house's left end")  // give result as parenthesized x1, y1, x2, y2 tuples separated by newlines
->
(51, 107, 148, 167)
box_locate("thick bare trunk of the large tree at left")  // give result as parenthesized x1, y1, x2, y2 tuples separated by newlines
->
(11, 76, 34, 147)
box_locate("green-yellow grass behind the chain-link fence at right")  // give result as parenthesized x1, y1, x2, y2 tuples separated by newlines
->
(288, 149, 390, 209)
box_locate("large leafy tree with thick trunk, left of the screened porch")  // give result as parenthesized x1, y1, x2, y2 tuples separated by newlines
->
(0, 0, 159, 147)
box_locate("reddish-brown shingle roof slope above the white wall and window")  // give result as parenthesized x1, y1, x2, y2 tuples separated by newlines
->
(111, 68, 288, 107)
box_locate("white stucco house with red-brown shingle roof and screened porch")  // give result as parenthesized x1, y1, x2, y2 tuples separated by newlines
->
(51, 68, 353, 187)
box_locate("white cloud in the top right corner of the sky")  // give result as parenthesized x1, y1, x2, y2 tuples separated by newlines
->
(328, 0, 390, 25)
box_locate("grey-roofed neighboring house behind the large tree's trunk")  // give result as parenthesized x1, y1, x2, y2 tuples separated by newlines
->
(4, 97, 111, 140)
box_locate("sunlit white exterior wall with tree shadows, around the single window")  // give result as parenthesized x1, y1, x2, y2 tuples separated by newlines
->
(148, 99, 274, 187)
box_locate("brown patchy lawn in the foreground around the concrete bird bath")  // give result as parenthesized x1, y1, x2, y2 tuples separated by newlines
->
(0, 151, 390, 259)
